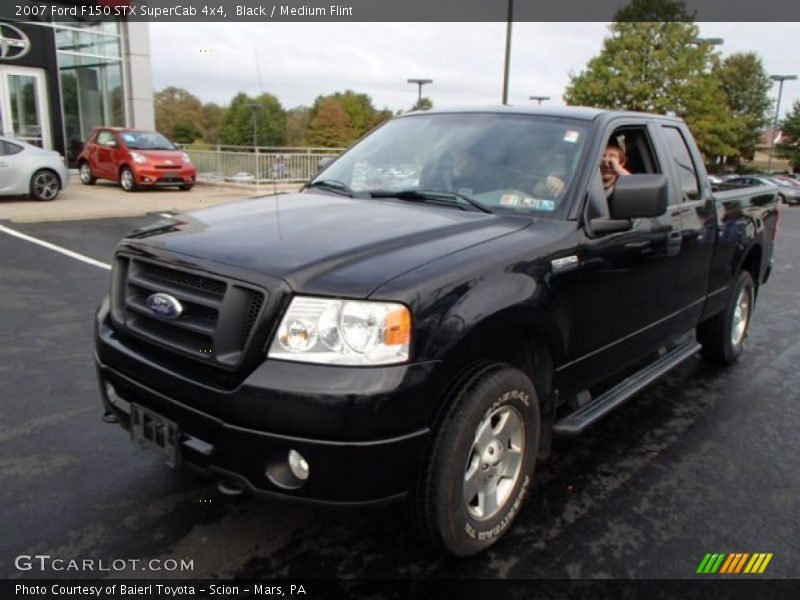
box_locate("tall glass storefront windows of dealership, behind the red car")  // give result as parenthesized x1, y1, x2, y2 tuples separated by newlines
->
(53, 22, 125, 158)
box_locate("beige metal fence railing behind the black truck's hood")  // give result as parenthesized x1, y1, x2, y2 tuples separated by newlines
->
(183, 144, 343, 184)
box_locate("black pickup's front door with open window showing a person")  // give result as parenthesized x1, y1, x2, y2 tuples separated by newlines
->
(559, 123, 681, 387)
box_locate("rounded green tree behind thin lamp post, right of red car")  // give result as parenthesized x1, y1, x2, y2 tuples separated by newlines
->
(219, 92, 286, 146)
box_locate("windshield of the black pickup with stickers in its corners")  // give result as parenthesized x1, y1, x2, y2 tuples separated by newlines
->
(312, 113, 588, 215)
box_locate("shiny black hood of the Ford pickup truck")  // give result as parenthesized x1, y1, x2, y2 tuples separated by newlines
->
(124, 193, 530, 298)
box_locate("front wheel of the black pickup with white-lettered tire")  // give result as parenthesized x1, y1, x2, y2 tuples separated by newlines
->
(407, 363, 540, 556)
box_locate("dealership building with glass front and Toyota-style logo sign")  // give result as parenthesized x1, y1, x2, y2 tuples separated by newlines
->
(0, 21, 155, 163)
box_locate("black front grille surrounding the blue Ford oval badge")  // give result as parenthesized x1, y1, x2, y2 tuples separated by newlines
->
(111, 255, 266, 369)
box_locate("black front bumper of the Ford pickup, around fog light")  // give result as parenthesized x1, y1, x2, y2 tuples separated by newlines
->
(96, 316, 440, 505)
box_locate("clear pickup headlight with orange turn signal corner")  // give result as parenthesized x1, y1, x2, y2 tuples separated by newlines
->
(269, 296, 411, 365)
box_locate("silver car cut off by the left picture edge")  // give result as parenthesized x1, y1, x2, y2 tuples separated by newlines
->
(0, 136, 69, 200)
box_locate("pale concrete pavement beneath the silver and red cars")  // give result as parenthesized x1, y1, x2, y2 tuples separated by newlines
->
(0, 180, 301, 223)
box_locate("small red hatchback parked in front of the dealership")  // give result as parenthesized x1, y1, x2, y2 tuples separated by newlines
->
(78, 127, 197, 192)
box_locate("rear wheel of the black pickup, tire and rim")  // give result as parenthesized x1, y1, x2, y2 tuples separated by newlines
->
(697, 271, 756, 365)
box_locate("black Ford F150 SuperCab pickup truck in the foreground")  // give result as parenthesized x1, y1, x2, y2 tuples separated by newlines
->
(96, 108, 779, 556)
